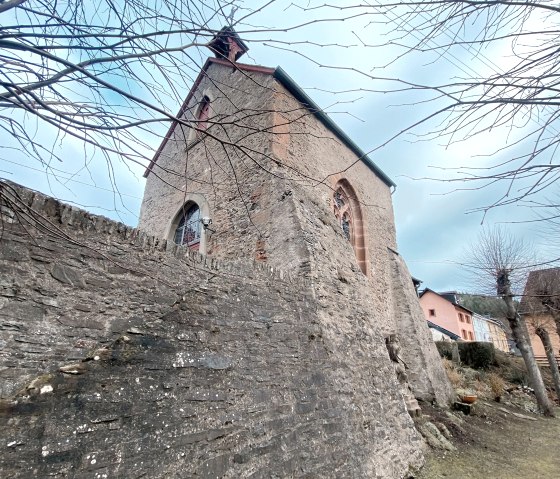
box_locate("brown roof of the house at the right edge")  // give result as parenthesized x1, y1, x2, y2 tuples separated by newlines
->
(519, 268, 560, 314)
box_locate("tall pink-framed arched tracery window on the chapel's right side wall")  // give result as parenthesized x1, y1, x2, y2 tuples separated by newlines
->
(333, 180, 368, 275)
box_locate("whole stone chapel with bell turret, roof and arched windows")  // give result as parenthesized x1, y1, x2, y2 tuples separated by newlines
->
(139, 27, 450, 407)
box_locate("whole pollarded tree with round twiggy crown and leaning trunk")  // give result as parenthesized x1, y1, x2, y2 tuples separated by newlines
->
(467, 227, 554, 416)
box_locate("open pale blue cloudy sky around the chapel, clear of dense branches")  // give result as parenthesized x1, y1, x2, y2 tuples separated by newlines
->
(0, 1, 554, 292)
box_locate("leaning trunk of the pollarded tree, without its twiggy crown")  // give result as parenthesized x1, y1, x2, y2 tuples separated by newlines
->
(501, 292, 554, 417)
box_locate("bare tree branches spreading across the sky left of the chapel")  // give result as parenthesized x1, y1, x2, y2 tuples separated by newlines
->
(0, 0, 354, 216)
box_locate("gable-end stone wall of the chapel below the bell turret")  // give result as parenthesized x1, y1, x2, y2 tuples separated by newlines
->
(139, 64, 309, 273)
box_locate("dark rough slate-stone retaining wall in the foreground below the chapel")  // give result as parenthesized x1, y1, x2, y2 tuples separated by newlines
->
(0, 184, 422, 478)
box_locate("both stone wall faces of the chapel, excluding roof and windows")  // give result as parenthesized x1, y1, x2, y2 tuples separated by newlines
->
(139, 64, 451, 404)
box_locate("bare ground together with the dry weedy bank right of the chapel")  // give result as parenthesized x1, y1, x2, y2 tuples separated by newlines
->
(411, 351, 560, 479)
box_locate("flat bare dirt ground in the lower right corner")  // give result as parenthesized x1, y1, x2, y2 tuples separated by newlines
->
(414, 401, 560, 479)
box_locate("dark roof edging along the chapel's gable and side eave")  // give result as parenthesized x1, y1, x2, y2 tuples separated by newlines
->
(144, 57, 396, 187)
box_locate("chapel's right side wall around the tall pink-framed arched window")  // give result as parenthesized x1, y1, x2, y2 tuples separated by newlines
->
(268, 79, 453, 405)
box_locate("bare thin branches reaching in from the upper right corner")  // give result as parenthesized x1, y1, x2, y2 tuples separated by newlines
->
(290, 0, 560, 218)
